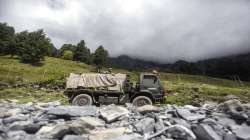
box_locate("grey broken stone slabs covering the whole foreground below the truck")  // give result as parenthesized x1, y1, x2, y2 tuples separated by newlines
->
(0, 99, 250, 140)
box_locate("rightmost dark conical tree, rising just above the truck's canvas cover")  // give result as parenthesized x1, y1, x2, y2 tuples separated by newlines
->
(93, 46, 108, 69)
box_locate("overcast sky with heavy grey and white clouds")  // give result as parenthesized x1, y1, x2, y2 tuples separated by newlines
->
(0, 0, 250, 63)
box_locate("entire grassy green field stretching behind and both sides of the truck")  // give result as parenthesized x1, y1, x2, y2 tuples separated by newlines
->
(0, 56, 250, 105)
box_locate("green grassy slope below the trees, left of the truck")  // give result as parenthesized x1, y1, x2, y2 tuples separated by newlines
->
(0, 56, 94, 84)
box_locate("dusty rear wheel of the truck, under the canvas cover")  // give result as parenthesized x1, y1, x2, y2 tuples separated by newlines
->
(72, 94, 93, 106)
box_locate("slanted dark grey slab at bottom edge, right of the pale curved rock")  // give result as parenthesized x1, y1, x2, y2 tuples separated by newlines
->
(192, 124, 223, 140)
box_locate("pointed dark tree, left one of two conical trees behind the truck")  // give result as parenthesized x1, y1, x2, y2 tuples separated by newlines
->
(73, 40, 91, 64)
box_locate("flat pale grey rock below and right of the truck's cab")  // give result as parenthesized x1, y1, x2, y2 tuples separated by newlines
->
(177, 108, 206, 121)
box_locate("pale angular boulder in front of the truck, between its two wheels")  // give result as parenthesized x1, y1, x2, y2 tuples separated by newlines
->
(100, 104, 129, 123)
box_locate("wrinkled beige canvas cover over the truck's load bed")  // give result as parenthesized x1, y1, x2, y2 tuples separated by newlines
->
(66, 73, 126, 91)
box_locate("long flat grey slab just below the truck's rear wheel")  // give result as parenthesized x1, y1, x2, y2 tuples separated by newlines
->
(47, 106, 97, 117)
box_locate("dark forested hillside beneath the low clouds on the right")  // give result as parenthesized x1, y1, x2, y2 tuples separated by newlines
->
(110, 52, 250, 81)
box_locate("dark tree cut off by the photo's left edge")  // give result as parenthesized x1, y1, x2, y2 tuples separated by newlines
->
(0, 23, 16, 56)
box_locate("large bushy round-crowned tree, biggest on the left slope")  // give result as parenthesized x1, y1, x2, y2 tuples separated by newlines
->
(16, 30, 52, 64)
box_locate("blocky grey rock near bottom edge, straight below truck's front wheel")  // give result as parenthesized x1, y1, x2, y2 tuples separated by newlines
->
(135, 118, 155, 135)
